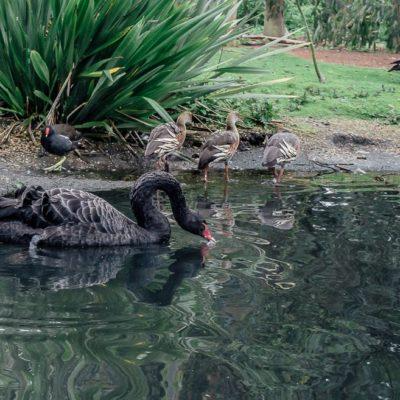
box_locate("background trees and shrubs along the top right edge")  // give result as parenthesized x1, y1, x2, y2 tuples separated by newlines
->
(239, 0, 400, 51)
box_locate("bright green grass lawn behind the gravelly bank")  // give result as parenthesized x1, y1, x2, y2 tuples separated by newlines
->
(225, 50, 400, 124)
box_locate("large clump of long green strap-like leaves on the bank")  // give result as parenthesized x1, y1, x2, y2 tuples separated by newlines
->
(0, 0, 302, 128)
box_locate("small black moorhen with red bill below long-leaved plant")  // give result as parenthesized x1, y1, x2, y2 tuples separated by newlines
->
(40, 124, 81, 172)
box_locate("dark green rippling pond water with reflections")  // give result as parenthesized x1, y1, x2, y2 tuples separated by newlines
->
(0, 174, 400, 400)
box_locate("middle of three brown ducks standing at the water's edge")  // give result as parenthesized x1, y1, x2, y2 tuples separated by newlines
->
(198, 111, 243, 182)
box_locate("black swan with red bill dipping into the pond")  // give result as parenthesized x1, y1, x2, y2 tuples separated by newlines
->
(0, 171, 214, 247)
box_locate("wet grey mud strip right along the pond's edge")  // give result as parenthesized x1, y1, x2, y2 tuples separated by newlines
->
(0, 148, 400, 195)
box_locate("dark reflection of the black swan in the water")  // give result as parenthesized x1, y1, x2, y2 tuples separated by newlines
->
(0, 244, 209, 305)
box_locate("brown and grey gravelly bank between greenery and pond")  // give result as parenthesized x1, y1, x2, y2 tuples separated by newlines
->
(0, 119, 400, 195)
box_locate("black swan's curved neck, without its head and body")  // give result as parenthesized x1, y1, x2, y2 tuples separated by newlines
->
(131, 172, 190, 243)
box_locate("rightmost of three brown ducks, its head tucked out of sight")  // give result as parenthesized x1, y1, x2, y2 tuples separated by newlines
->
(262, 131, 300, 183)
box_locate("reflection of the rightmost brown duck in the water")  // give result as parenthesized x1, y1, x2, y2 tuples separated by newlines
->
(257, 188, 296, 231)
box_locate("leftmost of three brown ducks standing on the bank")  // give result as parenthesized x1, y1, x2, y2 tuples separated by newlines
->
(144, 111, 193, 172)
